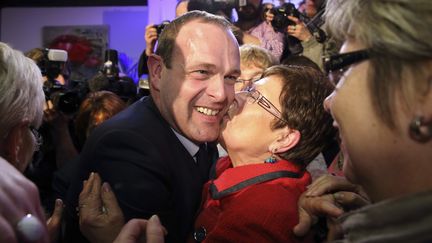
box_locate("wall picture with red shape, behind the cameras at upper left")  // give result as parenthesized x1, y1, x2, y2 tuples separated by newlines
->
(42, 25, 109, 81)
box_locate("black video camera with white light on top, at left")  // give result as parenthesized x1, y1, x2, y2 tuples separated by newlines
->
(38, 49, 87, 114)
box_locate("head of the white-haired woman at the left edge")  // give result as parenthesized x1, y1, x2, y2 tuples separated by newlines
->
(0, 43, 45, 172)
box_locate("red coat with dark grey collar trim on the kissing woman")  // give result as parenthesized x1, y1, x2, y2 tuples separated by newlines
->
(191, 157, 311, 243)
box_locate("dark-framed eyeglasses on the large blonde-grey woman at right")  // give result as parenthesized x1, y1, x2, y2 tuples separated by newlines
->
(323, 50, 371, 85)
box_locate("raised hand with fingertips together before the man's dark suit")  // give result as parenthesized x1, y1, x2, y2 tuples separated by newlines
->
(79, 173, 124, 243)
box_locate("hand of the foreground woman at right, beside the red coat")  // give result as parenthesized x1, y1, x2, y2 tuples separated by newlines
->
(293, 175, 369, 236)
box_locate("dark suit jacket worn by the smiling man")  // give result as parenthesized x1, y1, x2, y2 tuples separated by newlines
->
(63, 97, 211, 242)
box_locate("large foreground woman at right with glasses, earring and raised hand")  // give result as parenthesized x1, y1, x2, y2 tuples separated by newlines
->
(296, 0, 432, 242)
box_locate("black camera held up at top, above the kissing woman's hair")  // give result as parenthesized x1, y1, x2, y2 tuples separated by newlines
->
(271, 3, 302, 32)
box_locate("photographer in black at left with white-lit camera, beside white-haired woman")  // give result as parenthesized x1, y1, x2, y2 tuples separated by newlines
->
(25, 48, 78, 215)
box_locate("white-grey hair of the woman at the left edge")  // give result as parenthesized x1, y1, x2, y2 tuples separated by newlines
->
(0, 42, 45, 138)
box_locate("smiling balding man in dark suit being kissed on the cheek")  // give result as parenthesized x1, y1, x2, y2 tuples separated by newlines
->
(63, 11, 240, 242)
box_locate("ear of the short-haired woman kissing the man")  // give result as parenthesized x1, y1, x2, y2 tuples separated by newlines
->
(269, 127, 301, 153)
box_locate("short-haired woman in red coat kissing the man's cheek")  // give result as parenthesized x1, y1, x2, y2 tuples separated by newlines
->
(191, 66, 333, 242)
